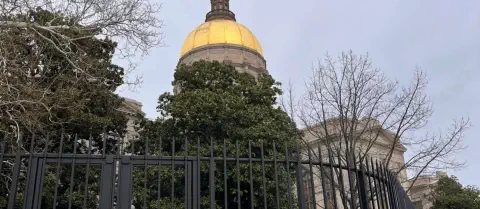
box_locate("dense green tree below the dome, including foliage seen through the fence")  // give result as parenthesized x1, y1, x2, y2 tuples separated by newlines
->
(130, 61, 300, 208)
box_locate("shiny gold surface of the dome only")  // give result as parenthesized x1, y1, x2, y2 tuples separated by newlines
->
(180, 19, 263, 57)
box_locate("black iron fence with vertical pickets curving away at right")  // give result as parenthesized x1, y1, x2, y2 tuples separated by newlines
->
(0, 134, 414, 209)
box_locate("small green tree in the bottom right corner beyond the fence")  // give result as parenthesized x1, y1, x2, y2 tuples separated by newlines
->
(432, 176, 480, 209)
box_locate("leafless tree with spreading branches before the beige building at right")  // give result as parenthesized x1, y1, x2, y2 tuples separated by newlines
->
(281, 51, 470, 207)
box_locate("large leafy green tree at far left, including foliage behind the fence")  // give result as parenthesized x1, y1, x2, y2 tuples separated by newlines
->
(0, 0, 163, 208)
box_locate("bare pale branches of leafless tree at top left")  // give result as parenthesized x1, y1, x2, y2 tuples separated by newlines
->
(0, 0, 163, 138)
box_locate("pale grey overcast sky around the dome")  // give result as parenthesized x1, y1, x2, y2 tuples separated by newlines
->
(119, 0, 480, 186)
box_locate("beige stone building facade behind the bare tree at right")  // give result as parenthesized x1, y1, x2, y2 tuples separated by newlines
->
(302, 119, 408, 208)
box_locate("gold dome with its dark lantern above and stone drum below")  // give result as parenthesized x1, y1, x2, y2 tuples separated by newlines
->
(179, 0, 267, 76)
